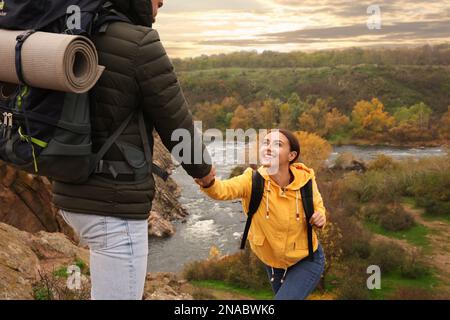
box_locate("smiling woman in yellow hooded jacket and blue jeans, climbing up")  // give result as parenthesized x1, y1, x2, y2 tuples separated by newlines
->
(196, 129, 326, 300)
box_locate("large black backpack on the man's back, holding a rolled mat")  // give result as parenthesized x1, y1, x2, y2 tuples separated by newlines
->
(0, 0, 168, 183)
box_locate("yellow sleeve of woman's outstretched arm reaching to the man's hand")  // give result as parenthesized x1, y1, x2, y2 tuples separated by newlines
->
(200, 168, 253, 200)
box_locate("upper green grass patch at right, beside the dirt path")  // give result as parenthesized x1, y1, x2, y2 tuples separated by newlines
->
(364, 221, 430, 249)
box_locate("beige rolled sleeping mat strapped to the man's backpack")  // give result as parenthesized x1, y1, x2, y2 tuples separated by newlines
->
(0, 29, 105, 93)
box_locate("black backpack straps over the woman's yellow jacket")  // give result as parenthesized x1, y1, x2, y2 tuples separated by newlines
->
(241, 170, 314, 261)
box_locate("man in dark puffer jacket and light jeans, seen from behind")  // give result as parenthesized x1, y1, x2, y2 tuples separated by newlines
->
(53, 0, 214, 299)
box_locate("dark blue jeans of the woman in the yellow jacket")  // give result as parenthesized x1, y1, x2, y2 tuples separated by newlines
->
(266, 244, 325, 300)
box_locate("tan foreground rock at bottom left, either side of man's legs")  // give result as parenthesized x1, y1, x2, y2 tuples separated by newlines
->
(0, 223, 195, 300)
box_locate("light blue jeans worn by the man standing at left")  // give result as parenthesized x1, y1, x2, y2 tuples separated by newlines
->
(60, 210, 148, 300)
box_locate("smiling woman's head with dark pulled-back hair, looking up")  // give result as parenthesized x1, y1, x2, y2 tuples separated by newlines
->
(260, 130, 297, 167)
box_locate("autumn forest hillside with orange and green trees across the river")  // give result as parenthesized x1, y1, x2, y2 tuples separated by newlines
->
(174, 45, 450, 145)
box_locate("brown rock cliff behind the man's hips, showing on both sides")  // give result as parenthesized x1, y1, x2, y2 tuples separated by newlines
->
(0, 134, 187, 239)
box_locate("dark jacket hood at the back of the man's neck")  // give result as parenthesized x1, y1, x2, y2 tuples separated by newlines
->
(110, 0, 153, 27)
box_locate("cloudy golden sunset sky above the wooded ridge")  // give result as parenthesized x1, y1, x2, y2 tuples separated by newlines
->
(154, 0, 450, 58)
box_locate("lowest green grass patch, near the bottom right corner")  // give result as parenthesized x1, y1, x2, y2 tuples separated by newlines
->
(370, 271, 439, 300)
